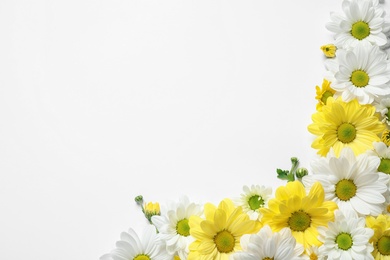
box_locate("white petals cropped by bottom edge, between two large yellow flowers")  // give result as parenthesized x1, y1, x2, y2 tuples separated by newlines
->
(232, 225, 306, 260)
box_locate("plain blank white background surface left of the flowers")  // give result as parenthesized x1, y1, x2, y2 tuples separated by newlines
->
(0, 0, 384, 260)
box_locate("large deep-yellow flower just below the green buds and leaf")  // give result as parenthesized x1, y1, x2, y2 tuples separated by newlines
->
(260, 181, 337, 248)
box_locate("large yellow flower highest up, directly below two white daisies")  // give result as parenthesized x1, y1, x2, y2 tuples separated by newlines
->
(308, 97, 385, 156)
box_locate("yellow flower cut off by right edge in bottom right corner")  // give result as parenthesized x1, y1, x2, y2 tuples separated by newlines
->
(366, 215, 390, 260)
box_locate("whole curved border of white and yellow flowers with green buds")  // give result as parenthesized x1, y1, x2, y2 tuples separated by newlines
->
(101, 0, 390, 260)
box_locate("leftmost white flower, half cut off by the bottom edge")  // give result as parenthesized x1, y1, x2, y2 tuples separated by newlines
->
(100, 225, 172, 260)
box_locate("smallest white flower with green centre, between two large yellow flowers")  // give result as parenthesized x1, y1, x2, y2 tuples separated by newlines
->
(235, 185, 272, 220)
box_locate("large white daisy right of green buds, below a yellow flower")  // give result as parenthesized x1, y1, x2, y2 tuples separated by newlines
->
(302, 147, 389, 216)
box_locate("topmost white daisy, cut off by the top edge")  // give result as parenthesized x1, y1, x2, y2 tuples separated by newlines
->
(326, 0, 390, 49)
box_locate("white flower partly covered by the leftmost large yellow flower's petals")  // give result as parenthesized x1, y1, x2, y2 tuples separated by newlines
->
(152, 196, 202, 259)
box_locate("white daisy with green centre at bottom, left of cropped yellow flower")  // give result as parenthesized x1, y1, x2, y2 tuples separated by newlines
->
(319, 210, 374, 260)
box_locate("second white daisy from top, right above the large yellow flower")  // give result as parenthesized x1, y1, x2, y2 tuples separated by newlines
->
(325, 46, 390, 104)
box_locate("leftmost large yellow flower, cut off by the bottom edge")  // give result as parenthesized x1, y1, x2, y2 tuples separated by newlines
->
(188, 199, 262, 260)
